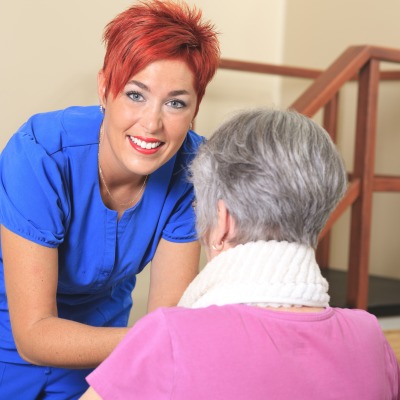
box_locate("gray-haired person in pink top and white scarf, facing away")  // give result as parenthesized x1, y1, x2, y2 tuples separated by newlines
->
(84, 110, 399, 400)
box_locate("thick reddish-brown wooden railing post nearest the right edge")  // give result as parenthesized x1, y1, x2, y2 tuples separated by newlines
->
(347, 59, 379, 309)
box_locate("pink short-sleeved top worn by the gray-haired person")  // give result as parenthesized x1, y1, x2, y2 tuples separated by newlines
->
(87, 305, 400, 400)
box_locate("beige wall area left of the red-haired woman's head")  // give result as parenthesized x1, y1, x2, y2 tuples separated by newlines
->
(0, 0, 130, 144)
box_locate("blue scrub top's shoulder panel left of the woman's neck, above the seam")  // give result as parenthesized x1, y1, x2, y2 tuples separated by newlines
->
(14, 106, 102, 154)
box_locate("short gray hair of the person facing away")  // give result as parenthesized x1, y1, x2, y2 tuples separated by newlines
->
(190, 109, 347, 247)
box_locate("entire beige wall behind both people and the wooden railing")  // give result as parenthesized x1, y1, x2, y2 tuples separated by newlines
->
(0, 0, 400, 321)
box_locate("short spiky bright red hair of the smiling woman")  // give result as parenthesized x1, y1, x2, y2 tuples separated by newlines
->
(103, 0, 220, 114)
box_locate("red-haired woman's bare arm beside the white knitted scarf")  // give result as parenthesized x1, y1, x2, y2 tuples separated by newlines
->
(147, 239, 200, 312)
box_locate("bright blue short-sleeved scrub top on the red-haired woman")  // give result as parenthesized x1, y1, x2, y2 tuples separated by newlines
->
(0, 106, 203, 362)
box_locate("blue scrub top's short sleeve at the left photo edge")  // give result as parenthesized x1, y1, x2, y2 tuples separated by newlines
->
(0, 128, 69, 247)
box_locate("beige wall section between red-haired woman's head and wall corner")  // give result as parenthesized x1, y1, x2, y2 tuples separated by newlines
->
(190, 0, 285, 135)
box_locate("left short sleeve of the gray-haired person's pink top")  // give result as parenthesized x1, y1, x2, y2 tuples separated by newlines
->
(86, 309, 174, 400)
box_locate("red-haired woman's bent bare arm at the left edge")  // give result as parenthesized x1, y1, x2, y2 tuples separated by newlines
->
(1, 226, 128, 368)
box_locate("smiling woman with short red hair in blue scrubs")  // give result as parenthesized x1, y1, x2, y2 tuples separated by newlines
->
(0, 0, 219, 399)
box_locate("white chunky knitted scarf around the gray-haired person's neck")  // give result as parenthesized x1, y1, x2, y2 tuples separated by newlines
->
(178, 241, 329, 308)
